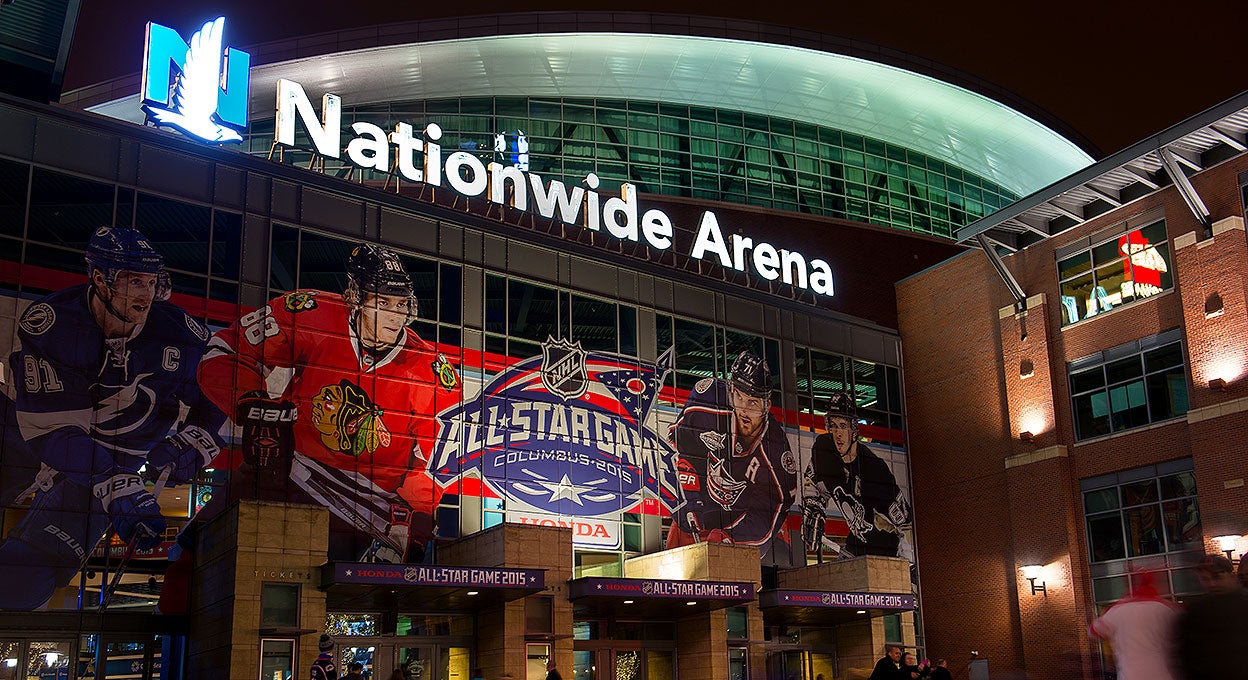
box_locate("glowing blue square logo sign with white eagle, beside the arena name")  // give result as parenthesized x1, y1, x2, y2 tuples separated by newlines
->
(142, 16, 251, 143)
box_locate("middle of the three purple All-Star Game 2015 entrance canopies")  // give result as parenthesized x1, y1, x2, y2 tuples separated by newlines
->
(568, 576, 755, 620)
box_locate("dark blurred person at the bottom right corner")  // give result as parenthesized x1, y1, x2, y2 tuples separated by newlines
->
(1174, 555, 1248, 680)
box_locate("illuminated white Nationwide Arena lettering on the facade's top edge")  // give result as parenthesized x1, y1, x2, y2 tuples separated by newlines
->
(275, 79, 832, 296)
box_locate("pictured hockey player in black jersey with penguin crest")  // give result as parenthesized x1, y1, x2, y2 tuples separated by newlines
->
(802, 392, 914, 561)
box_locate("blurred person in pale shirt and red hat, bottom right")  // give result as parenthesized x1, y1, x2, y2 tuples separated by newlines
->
(1088, 571, 1179, 680)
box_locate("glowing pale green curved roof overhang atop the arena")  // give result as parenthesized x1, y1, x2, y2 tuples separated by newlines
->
(90, 32, 1092, 195)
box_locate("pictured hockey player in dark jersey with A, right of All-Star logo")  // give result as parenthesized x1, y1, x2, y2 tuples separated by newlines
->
(668, 351, 797, 564)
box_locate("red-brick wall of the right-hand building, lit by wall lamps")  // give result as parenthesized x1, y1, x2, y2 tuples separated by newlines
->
(897, 155, 1248, 678)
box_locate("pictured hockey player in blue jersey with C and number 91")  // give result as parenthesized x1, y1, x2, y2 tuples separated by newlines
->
(0, 227, 225, 610)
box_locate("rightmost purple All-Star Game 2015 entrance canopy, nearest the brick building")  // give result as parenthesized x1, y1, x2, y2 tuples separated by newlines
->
(759, 590, 915, 625)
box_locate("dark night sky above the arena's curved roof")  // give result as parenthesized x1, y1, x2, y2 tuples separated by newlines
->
(65, 0, 1248, 153)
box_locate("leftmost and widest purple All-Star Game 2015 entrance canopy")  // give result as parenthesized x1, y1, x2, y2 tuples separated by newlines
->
(321, 561, 545, 611)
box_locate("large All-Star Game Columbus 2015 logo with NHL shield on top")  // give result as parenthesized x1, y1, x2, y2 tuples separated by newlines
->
(429, 341, 684, 548)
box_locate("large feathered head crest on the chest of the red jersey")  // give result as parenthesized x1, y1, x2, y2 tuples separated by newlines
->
(312, 379, 391, 457)
